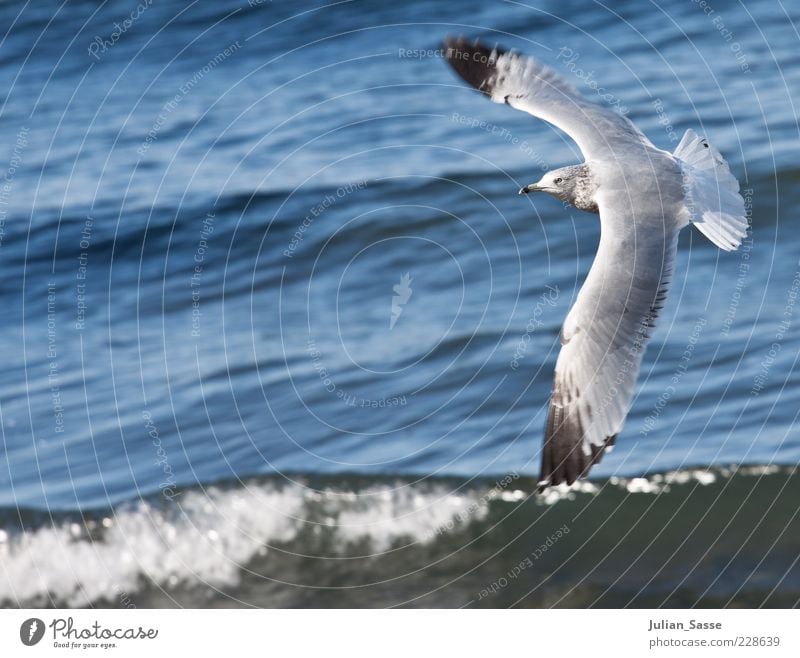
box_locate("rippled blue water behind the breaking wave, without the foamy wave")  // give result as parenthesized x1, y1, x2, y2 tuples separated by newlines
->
(0, 0, 800, 598)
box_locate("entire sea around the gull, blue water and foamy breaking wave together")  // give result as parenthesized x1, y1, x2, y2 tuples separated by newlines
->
(0, 0, 800, 607)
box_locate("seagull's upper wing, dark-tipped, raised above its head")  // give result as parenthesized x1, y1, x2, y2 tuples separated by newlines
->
(444, 37, 655, 160)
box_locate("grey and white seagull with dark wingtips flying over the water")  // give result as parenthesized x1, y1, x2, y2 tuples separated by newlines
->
(445, 37, 747, 490)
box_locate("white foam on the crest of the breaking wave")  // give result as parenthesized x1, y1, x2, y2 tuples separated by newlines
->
(0, 476, 486, 606)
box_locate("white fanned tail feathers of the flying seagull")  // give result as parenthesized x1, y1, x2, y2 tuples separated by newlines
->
(673, 130, 747, 251)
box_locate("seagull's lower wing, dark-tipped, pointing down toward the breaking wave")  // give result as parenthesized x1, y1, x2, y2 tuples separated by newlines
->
(539, 191, 679, 489)
